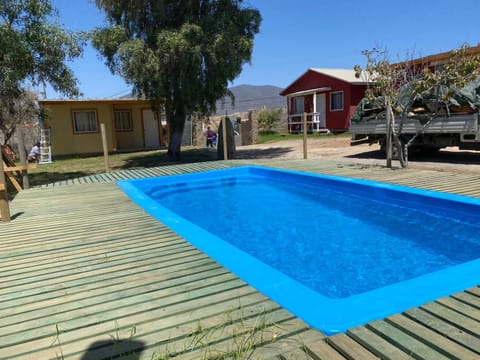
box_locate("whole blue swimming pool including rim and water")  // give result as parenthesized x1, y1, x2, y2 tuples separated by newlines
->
(119, 167, 480, 334)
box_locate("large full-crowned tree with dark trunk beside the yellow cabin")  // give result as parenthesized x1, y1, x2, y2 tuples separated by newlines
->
(92, 0, 261, 161)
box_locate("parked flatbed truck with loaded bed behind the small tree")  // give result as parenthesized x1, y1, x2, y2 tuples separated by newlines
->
(349, 78, 480, 154)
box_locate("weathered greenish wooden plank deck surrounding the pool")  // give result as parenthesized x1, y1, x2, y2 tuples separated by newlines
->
(0, 160, 480, 359)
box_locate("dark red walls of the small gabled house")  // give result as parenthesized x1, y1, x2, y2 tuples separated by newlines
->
(281, 70, 366, 130)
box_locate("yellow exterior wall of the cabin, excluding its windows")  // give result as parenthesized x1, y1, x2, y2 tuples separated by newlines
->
(39, 100, 154, 156)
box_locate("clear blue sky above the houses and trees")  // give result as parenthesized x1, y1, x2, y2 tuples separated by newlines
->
(46, 0, 480, 99)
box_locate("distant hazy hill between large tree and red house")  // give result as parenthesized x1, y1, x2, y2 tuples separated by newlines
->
(216, 85, 286, 115)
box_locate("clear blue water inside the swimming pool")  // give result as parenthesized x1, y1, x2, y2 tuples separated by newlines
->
(147, 175, 480, 298)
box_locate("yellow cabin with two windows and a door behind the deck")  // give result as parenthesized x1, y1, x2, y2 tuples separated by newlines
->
(38, 99, 168, 156)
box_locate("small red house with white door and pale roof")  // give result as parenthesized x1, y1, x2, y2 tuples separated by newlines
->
(280, 68, 367, 132)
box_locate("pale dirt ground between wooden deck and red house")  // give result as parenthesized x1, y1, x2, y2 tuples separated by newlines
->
(235, 135, 480, 175)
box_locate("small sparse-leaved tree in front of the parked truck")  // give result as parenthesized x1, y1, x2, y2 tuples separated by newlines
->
(354, 44, 480, 167)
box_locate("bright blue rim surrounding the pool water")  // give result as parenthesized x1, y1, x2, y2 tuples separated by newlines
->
(117, 166, 480, 335)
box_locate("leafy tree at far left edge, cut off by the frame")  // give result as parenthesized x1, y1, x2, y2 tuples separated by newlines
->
(0, 0, 84, 144)
